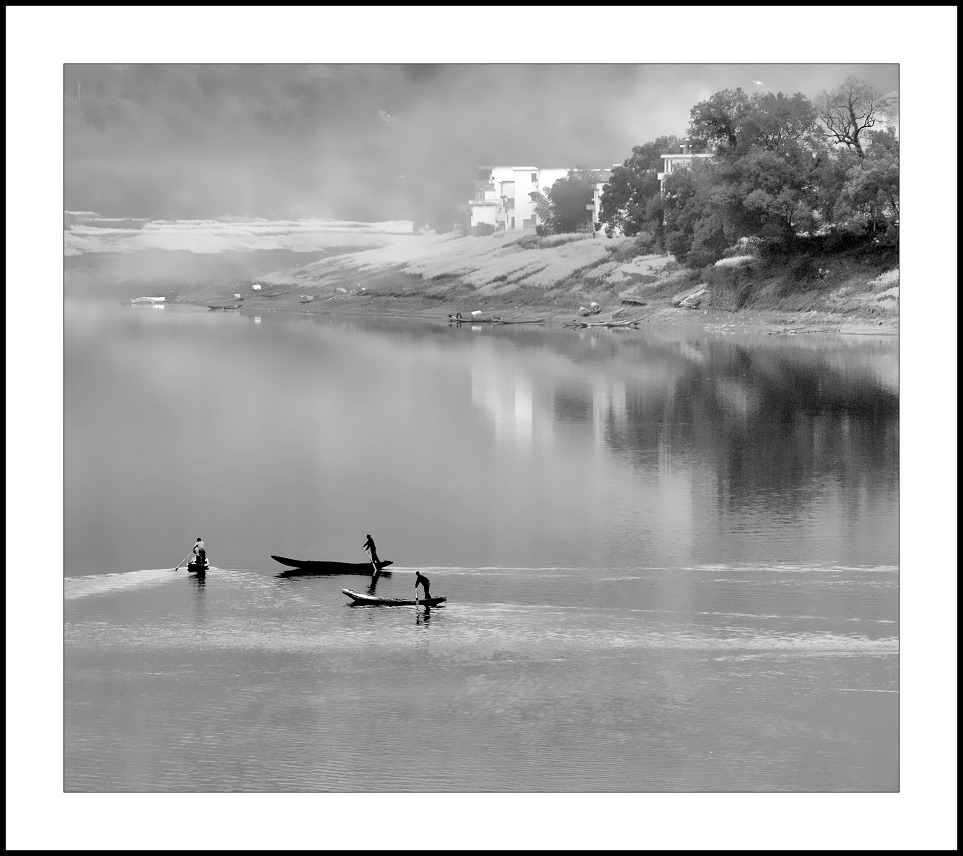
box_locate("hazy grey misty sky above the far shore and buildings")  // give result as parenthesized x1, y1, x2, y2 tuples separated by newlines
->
(63, 63, 899, 220)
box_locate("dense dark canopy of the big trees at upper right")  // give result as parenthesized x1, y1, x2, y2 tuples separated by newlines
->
(600, 78, 899, 266)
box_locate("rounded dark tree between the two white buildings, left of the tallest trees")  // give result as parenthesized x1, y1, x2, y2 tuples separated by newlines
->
(599, 136, 679, 238)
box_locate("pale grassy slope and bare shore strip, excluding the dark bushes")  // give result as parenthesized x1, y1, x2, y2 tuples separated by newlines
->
(185, 235, 899, 335)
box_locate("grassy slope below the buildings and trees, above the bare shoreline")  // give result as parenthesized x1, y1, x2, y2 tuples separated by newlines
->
(201, 227, 899, 323)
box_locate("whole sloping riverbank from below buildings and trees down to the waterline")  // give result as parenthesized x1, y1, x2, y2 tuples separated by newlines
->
(186, 232, 899, 335)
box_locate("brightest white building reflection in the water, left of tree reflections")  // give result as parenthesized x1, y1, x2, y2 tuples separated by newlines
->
(471, 353, 534, 446)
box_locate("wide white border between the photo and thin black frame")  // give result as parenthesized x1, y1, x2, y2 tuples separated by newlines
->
(6, 6, 957, 850)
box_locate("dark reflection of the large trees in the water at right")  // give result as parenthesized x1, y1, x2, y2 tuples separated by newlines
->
(605, 343, 899, 508)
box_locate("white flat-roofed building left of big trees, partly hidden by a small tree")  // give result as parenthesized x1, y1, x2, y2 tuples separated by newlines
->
(464, 166, 612, 234)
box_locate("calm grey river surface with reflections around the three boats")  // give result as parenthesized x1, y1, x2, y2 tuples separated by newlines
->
(64, 299, 899, 792)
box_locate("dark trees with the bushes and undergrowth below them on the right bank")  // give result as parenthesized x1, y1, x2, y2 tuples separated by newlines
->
(460, 78, 899, 318)
